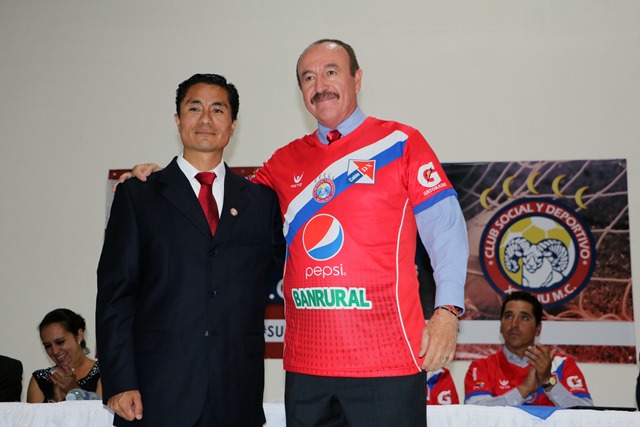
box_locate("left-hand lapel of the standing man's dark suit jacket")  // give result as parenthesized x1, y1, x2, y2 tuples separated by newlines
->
(158, 158, 211, 237)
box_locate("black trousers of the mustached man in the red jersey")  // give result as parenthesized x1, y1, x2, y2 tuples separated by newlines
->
(284, 372, 427, 427)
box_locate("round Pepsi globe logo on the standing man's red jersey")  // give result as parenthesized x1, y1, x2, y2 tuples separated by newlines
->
(302, 214, 344, 261)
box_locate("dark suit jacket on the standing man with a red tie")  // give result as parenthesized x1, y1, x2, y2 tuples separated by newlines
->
(96, 159, 285, 427)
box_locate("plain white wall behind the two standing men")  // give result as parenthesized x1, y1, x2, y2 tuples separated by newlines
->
(0, 0, 640, 406)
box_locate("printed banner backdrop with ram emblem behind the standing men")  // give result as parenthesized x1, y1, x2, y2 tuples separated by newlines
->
(107, 160, 636, 363)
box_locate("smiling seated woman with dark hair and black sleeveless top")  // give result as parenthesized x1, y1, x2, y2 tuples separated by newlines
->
(27, 308, 102, 403)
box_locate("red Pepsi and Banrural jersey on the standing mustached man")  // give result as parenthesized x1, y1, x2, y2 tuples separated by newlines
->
(252, 117, 455, 377)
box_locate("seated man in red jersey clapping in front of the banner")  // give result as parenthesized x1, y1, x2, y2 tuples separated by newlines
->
(464, 292, 593, 408)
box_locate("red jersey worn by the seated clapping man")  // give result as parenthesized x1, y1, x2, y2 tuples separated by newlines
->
(464, 351, 591, 406)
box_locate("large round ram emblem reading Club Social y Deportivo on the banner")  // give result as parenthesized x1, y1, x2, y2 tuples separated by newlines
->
(480, 199, 596, 308)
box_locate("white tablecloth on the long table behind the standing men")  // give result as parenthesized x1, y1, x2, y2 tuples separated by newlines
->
(0, 401, 640, 427)
